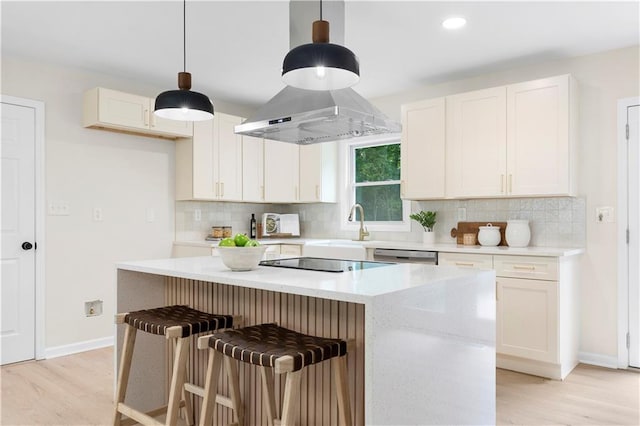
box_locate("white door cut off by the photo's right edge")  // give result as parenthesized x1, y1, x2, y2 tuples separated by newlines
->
(627, 105, 640, 368)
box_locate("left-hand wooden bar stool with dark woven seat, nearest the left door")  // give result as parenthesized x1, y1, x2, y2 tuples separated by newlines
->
(113, 305, 241, 426)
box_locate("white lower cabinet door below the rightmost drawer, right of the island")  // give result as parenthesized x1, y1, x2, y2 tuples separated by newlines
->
(496, 277, 559, 363)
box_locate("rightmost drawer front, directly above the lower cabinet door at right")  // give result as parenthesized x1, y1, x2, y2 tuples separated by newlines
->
(493, 256, 558, 281)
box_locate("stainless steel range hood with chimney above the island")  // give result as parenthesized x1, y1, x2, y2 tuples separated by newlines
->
(235, 1, 402, 145)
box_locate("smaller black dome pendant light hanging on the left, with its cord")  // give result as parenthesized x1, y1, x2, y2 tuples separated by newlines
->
(154, 0, 213, 121)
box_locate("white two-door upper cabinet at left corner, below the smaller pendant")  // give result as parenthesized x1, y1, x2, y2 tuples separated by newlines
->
(176, 112, 242, 201)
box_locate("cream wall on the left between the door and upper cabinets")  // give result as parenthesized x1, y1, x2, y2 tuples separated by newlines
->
(1, 56, 251, 353)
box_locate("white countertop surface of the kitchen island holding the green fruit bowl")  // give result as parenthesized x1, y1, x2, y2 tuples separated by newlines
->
(116, 256, 490, 303)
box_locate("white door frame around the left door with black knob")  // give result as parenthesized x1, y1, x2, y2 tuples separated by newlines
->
(0, 94, 46, 359)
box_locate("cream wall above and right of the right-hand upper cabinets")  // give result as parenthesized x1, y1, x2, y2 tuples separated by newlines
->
(373, 46, 640, 365)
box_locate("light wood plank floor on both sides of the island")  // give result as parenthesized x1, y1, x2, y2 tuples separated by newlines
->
(0, 348, 640, 426)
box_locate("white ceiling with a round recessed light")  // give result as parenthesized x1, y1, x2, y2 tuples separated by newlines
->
(0, 0, 640, 106)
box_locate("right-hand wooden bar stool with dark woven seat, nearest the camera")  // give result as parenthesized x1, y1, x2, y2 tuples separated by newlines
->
(198, 324, 352, 426)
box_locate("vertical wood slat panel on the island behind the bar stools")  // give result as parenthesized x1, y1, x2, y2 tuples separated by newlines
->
(165, 277, 365, 425)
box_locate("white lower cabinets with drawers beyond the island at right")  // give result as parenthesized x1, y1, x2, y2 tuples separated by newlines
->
(438, 253, 579, 380)
